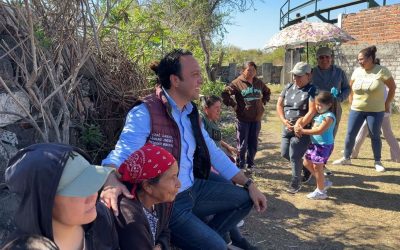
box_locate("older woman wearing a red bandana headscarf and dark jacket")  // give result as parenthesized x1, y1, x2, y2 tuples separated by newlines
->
(115, 143, 181, 250)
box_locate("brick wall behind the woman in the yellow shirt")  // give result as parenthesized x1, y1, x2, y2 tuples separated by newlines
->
(335, 4, 400, 108)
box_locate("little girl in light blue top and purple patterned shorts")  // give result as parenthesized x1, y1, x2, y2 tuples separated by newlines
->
(295, 91, 336, 200)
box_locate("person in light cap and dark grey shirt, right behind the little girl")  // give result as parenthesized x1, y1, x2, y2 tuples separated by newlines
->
(276, 62, 316, 194)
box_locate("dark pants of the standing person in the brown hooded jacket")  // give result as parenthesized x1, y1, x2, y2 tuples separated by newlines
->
(236, 121, 261, 168)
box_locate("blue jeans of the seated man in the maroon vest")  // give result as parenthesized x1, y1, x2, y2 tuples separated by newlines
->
(169, 179, 253, 250)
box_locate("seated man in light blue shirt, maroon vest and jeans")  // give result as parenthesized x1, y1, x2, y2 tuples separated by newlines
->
(102, 49, 266, 250)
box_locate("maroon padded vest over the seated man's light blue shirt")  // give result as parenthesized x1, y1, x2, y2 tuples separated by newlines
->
(135, 88, 211, 179)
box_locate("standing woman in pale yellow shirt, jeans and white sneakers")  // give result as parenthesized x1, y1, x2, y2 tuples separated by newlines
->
(333, 46, 396, 172)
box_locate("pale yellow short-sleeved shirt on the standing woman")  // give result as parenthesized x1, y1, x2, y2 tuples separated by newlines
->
(351, 65, 392, 112)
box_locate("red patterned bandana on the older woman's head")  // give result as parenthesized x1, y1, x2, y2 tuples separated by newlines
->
(118, 143, 175, 195)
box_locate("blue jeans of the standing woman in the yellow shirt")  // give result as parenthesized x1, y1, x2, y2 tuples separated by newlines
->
(344, 110, 385, 161)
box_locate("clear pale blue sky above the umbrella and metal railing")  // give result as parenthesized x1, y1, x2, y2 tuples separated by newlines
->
(223, 0, 400, 49)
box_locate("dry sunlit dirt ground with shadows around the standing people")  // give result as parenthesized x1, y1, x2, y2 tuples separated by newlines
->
(238, 93, 400, 249)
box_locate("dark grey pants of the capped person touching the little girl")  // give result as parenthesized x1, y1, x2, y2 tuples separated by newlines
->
(281, 127, 310, 181)
